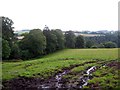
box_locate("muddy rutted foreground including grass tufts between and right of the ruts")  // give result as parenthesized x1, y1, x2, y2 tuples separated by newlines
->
(3, 60, 120, 90)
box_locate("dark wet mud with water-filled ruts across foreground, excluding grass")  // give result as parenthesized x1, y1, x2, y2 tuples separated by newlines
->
(3, 62, 120, 90)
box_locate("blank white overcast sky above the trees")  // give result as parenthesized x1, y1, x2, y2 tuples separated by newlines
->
(0, 0, 119, 31)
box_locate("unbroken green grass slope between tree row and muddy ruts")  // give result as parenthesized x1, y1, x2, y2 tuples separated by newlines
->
(2, 49, 118, 80)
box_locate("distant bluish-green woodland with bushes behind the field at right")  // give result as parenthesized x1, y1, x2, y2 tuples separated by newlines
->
(85, 31, 120, 48)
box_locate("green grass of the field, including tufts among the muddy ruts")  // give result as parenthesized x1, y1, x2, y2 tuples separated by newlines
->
(2, 49, 118, 88)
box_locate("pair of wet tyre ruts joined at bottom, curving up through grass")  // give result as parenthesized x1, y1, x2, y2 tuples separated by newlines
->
(39, 61, 111, 89)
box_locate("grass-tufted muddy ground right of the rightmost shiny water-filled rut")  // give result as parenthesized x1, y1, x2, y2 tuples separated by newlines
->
(88, 61, 120, 90)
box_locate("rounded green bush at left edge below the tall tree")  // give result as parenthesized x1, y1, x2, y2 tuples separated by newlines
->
(2, 39, 11, 59)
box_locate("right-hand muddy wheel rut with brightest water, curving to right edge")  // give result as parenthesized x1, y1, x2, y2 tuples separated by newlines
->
(65, 60, 120, 89)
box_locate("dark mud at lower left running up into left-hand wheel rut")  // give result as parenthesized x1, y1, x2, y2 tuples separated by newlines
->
(3, 61, 107, 90)
